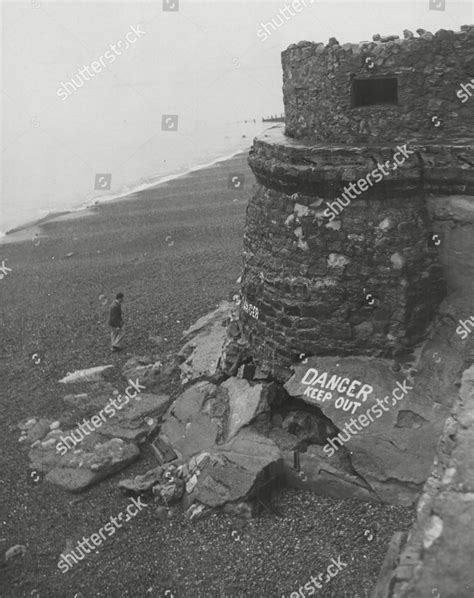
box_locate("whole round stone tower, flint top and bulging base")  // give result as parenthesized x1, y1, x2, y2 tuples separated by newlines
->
(241, 26, 474, 378)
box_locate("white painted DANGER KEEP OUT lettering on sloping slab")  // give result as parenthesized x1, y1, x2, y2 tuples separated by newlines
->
(301, 368, 374, 413)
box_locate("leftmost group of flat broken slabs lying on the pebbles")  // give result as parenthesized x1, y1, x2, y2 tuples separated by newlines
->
(18, 354, 179, 492)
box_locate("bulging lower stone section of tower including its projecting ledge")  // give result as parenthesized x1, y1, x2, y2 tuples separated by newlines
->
(241, 127, 474, 376)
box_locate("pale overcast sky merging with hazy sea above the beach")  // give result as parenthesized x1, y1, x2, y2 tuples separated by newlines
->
(0, 0, 474, 230)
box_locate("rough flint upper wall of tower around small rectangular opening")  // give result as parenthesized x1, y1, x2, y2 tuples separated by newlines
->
(282, 25, 474, 143)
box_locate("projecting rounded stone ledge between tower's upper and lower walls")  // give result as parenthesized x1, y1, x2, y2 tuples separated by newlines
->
(248, 125, 474, 198)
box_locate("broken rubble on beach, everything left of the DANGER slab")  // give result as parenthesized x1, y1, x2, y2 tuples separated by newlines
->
(19, 302, 288, 519)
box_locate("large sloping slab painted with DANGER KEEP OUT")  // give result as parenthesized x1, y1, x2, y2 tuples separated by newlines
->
(285, 357, 449, 505)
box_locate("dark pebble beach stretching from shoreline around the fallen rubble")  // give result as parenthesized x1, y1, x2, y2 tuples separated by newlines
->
(0, 153, 415, 598)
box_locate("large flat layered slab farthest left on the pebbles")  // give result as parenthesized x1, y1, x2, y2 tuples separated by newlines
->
(19, 383, 170, 492)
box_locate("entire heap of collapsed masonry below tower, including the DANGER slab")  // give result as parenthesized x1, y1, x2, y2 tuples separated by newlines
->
(16, 290, 472, 518)
